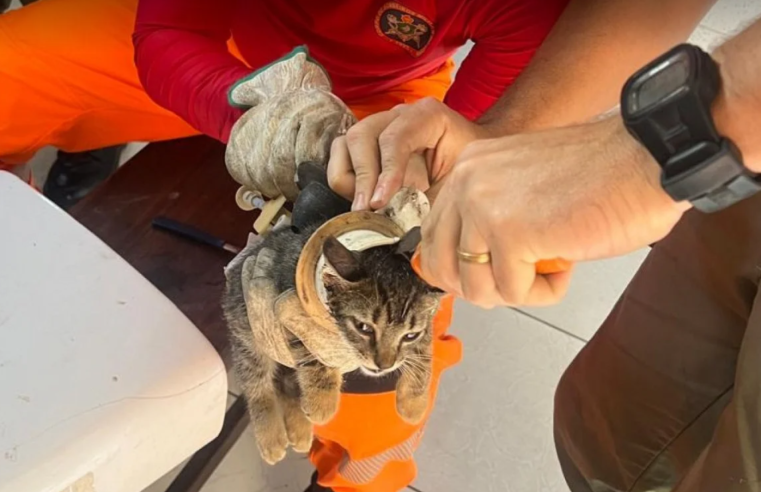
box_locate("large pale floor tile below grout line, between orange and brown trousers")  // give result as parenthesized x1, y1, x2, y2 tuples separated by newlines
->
(414, 304, 583, 492)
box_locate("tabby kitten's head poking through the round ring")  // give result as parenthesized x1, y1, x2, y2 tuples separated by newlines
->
(323, 238, 442, 376)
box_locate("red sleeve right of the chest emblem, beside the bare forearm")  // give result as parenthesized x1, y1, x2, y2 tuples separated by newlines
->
(445, 0, 568, 120)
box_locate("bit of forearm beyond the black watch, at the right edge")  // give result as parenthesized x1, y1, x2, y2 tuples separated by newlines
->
(713, 19, 761, 173)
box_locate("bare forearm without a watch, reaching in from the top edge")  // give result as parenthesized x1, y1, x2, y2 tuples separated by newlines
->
(479, 0, 715, 135)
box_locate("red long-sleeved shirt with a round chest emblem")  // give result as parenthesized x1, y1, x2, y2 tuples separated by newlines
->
(134, 0, 568, 141)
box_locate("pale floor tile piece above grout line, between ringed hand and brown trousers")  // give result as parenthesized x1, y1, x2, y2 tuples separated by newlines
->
(521, 249, 649, 340)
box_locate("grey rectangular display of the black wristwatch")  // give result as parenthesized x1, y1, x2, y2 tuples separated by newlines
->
(627, 52, 690, 114)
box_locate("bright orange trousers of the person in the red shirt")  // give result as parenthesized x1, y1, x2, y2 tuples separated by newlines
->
(0, 0, 461, 492)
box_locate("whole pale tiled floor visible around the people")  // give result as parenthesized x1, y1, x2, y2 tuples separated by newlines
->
(131, 0, 761, 492)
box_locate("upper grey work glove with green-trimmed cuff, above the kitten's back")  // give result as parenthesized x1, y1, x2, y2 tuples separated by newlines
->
(225, 47, 356, 201)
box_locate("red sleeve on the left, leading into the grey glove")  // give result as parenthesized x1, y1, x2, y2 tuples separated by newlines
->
(133, 0, 251, 142)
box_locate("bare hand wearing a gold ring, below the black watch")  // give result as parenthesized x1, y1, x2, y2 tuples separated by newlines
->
(420, 117, 689, 307)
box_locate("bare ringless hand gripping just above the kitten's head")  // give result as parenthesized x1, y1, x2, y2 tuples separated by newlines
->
(328, 98, 485, 210)
